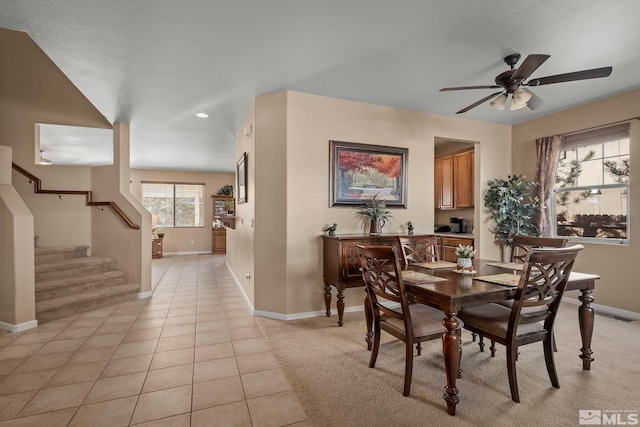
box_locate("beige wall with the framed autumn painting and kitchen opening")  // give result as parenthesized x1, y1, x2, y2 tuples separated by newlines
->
(227, 92, 511, 316)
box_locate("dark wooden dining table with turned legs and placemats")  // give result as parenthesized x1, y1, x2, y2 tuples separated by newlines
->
(365, 259, 600, 415)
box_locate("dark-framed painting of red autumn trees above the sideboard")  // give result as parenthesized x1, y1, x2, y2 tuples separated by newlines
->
(329, 140, 409, 208)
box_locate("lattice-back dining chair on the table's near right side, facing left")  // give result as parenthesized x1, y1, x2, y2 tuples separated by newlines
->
(458, 245, 583, 402)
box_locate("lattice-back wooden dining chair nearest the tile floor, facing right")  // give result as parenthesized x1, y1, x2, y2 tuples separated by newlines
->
(356, 245, 462, 396)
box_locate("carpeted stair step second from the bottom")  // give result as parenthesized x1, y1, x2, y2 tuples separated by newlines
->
(36, 270, 131, 301)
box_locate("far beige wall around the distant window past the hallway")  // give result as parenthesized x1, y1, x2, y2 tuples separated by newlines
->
(129, 169, 235, 253)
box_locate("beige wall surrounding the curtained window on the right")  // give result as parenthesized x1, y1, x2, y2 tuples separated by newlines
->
(512, 90, 640, 312)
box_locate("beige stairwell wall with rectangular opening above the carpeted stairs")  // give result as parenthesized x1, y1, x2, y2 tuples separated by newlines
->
(0, 29, 111, 249)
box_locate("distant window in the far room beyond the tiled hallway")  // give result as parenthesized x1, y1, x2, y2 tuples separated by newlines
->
(142, 182, 204, 227)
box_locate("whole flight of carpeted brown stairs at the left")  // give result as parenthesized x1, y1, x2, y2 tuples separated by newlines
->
(35, 246, 140, 323)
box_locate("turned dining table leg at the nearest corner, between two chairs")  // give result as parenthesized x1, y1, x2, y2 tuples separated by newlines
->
(442, 313, 460, 415)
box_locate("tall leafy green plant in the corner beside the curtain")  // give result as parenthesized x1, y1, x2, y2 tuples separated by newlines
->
(484, 175, 541, 259)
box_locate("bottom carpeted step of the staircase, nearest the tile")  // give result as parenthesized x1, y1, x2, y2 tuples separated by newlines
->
(36, 284, 140, 323)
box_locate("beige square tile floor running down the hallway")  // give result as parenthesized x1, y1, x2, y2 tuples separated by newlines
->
(0, 255, 309, 427)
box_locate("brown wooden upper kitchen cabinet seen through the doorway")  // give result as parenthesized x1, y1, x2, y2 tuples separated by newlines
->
(434, 150, 474, 209)
